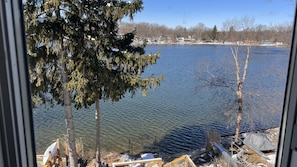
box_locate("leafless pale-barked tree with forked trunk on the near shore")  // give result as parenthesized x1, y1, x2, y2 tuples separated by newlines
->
(197, 46, 285, 142)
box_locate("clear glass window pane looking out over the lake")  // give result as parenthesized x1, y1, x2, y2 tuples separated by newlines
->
(24, 0, 295, 165)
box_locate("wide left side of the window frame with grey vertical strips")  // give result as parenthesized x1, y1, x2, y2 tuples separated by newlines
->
(0, 0, 37, 167)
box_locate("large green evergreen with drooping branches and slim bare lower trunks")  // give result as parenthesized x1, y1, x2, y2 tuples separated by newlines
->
(24, 0, 162, 166)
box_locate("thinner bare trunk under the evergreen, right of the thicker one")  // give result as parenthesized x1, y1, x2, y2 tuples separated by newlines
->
(95, 99, 100, 167)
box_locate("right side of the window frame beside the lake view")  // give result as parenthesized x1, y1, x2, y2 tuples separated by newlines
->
(275, 4, 297, 167)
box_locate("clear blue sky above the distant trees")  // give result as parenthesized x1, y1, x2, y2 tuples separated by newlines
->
(126, 0, 295, 29)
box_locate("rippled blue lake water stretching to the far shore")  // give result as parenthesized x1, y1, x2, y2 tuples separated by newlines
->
(33, 45, 289, 157)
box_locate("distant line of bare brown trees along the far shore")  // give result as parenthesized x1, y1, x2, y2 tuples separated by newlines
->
(119, 17, 293, 45)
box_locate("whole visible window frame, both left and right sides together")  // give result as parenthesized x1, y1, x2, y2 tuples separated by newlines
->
(0, 0, 297, 167)
